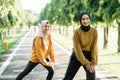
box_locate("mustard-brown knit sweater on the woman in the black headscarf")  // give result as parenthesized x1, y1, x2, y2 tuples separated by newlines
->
(73, 27, 98, 65)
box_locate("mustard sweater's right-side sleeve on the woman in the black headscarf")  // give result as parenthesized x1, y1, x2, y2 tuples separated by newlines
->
(91, 29, 98, 65)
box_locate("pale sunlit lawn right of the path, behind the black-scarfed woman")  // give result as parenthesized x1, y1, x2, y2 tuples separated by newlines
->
(52, 29, 120, 78)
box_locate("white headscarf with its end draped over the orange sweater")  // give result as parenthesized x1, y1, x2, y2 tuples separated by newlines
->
(35, 20, 50, 50)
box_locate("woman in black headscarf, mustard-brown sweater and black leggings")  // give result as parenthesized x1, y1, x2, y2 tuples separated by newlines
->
(63, 12, 98, 80)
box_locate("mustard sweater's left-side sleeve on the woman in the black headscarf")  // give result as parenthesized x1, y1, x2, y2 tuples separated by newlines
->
(73, 30, 90, 65)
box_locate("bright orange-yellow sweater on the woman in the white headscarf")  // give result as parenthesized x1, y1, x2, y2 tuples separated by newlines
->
(30, 35, 55, 66)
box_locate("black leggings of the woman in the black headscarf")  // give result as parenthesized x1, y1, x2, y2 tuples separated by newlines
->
(63, 51, 95, 80)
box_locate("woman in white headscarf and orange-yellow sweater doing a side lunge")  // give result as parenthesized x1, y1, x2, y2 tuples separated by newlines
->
(16, 20, 55, 80)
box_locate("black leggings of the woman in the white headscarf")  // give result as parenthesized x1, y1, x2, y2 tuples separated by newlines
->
(16, 58, 54, 80)
